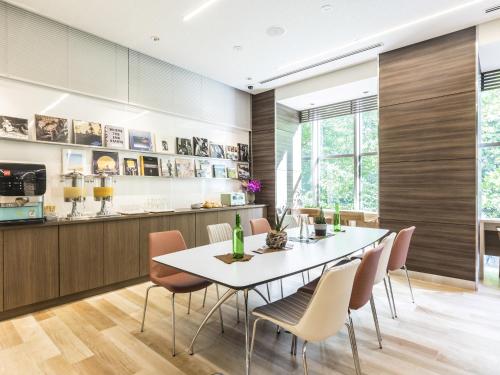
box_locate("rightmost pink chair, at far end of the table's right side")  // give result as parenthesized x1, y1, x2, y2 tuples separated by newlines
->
(387, 226, 415, 318)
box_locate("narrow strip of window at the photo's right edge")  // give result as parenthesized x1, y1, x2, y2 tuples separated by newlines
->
(479, 88, 500, 218)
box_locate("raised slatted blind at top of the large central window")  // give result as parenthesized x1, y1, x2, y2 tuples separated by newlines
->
(300, 95, 378, 122)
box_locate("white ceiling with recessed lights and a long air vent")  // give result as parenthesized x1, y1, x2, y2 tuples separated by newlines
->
(4, 0, 500, 92)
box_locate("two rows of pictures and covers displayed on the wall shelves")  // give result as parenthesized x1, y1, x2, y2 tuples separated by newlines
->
(0, 114, 250, 180)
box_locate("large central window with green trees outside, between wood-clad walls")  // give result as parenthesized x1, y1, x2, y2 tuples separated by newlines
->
(295, 101, 378, 211)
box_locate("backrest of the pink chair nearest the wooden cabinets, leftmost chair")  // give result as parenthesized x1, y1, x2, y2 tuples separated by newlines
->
(149, 230, 187, 278)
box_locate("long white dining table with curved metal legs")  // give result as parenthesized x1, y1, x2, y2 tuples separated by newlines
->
(153, 227, 389, 375)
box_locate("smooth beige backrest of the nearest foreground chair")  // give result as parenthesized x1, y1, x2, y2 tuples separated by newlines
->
(295, 259, 360, 341)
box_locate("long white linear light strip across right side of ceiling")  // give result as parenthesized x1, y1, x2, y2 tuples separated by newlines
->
(278, 0, 484, 70)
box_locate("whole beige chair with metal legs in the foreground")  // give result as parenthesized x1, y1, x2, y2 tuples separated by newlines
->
(250, 259, 361, 375)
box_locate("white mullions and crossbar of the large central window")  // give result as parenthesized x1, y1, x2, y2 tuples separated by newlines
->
(302, 110, 379, 211)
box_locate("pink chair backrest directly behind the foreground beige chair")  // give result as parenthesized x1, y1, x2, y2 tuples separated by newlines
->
(349, 244, 384, 310)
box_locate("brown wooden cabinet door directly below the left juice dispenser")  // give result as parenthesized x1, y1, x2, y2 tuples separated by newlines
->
(59, 223, 104, 296)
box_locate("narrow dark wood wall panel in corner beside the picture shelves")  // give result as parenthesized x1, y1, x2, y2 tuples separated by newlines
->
(251, 90, 276, 226)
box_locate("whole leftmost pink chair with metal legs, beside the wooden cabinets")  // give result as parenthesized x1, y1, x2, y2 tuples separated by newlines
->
(141, 230, 224, 356)
